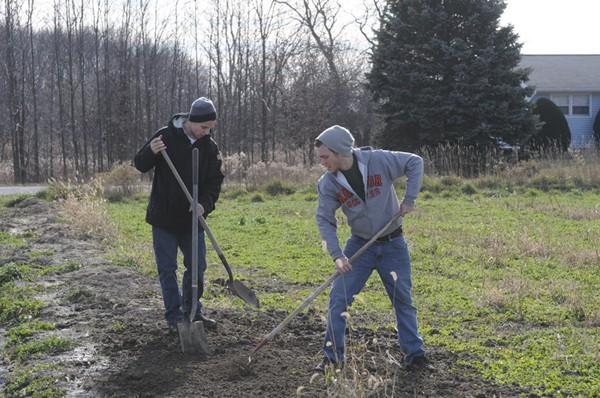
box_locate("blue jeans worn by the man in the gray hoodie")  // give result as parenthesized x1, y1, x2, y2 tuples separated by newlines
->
(323, 236, 425, 362)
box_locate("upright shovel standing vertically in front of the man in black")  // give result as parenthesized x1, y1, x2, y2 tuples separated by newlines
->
(177, 148, 210, 355)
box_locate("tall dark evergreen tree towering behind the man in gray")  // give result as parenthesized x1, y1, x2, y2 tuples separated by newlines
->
(367, 0, 534, 149)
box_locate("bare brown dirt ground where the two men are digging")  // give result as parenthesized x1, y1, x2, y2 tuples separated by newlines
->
(0, 199, 527, 397)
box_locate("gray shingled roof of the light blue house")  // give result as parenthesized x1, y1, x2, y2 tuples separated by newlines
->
(520, 54, 600, 92)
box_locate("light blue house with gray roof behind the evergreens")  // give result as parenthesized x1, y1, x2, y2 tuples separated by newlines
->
(520, 54, 600, 148)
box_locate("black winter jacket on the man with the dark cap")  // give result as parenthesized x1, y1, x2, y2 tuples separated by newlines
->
(134, 114, 224, 232)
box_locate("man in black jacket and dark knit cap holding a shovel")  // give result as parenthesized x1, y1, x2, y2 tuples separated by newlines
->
(135, 97, 224, 330)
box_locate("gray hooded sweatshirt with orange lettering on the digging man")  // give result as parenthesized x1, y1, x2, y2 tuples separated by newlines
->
(316, 147, 423, 260)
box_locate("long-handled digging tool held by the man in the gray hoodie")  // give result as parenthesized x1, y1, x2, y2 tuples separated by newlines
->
(237, 211, 402, 375)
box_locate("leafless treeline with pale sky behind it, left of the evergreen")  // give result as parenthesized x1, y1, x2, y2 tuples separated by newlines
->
(0, 0, 376, 183)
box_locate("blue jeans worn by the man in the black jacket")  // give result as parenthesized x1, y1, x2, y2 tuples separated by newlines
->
(152, 226, 206, 322)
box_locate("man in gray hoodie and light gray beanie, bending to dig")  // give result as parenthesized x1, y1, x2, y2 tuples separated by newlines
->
(315, 125, 431, 371)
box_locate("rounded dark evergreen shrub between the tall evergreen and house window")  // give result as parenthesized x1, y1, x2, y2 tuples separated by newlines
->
(529, 98, 571, 152)
